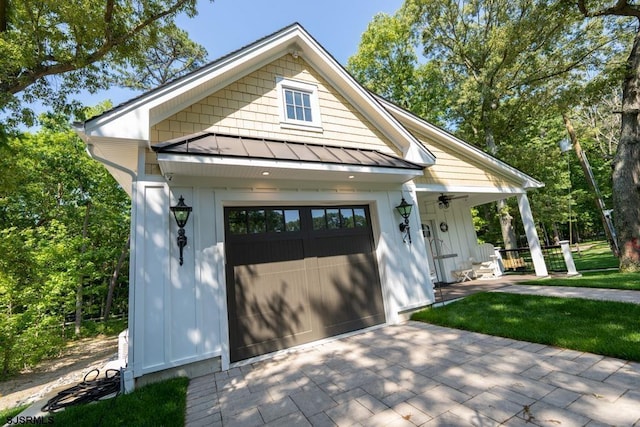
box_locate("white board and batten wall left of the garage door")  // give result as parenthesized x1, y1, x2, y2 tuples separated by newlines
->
(129, 181, 223, 377)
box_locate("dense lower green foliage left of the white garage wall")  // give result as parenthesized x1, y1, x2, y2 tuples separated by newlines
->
(0, 116, 129, 376)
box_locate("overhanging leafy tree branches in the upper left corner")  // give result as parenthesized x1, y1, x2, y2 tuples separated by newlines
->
(0, 0, 206, 131)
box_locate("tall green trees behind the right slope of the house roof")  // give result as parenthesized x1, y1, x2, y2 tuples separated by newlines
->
(348, 0, 640, 265)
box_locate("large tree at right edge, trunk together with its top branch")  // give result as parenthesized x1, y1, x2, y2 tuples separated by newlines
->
(577, 0, 640, 272)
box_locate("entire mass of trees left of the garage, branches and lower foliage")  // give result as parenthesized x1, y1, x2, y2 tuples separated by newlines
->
(0, 0, 207, 378)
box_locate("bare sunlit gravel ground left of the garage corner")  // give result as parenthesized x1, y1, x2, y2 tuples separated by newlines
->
(0, 337, 118, 410)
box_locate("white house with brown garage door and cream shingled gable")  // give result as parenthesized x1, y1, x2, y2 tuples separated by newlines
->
(76, 24, 547, 389)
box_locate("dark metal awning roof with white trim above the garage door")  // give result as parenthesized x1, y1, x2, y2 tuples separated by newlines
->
(153, 133, 424, 183)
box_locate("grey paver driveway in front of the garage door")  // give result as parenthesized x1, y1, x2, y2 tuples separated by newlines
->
(186, 322, 640, 427)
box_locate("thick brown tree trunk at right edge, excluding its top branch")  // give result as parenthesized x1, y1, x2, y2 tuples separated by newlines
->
(612, 27, 640, 272)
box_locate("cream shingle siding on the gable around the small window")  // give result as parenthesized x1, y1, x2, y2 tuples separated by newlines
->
(150, 55, 399, 155)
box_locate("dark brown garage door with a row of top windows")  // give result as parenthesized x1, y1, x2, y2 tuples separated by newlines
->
(225, 206, 385, 361)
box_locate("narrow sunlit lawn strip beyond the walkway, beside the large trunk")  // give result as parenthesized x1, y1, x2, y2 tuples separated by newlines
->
(518, 271, 640, 291)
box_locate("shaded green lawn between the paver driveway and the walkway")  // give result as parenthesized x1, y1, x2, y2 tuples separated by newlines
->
(411, 292, 640, 361)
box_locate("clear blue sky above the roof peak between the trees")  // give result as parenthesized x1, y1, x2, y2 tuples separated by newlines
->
(79, 0, 403, 110)
